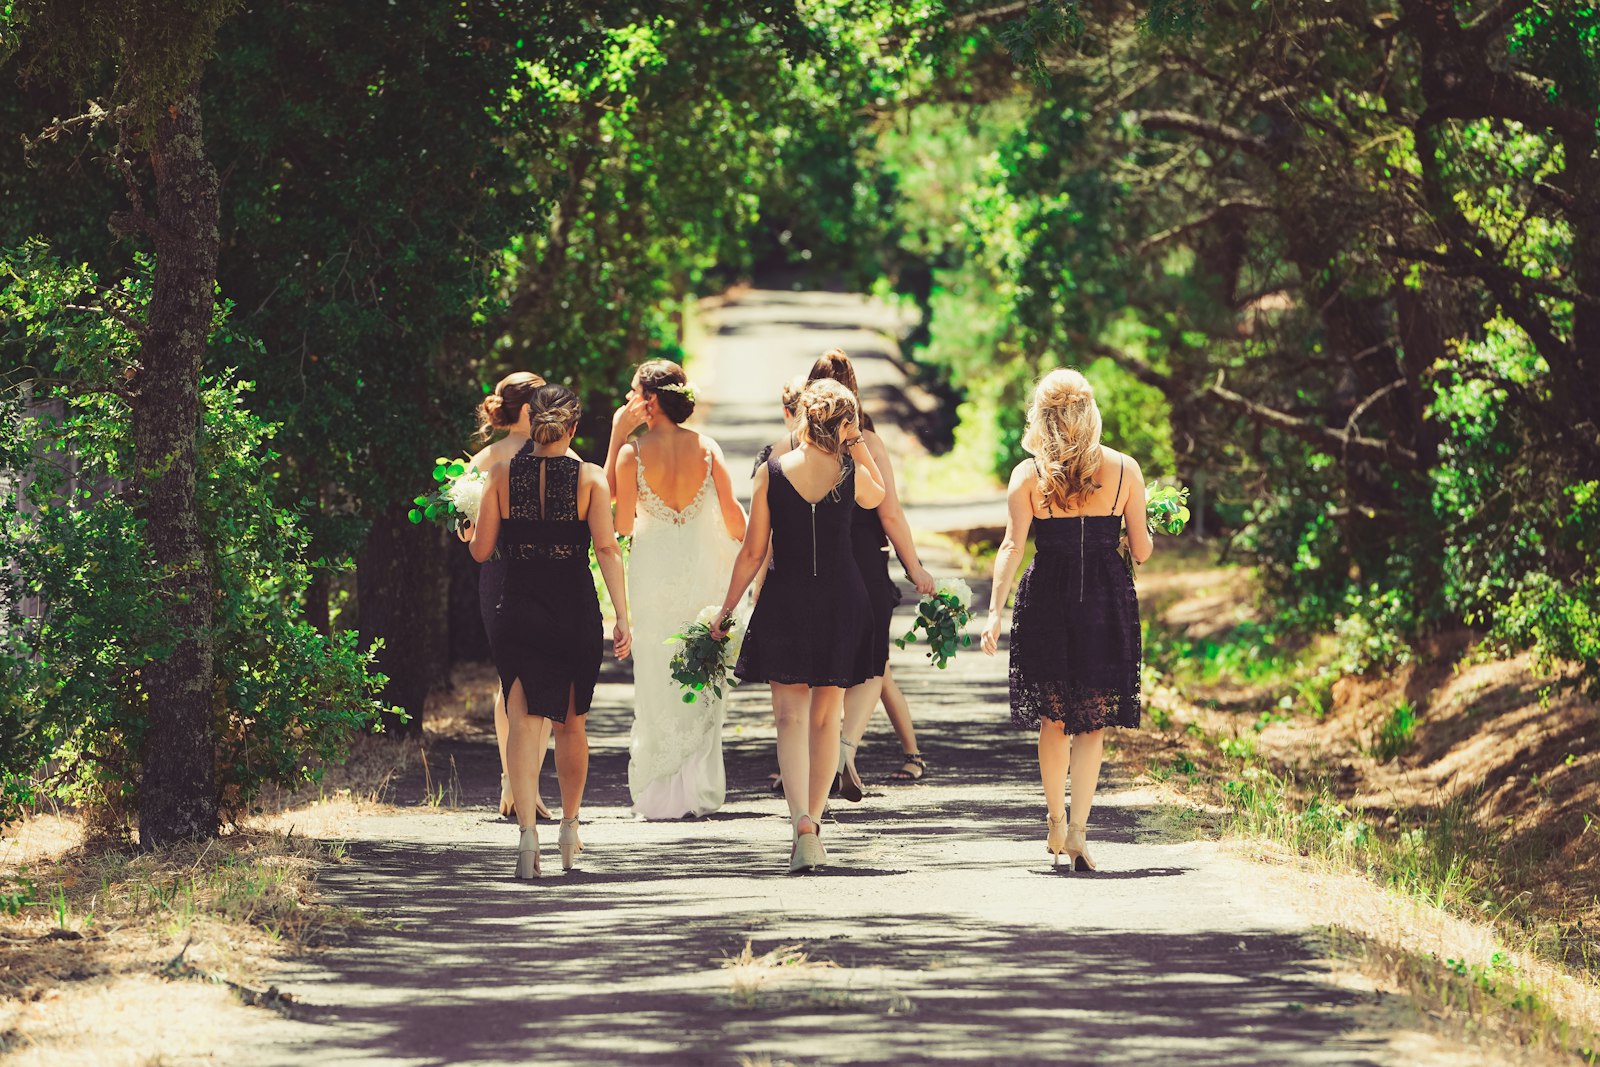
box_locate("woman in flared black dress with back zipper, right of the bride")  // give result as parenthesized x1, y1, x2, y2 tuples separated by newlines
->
(712, 381, 883, 872)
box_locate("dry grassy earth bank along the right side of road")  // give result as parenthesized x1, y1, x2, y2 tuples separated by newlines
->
(1118, 556, 1600, 1062)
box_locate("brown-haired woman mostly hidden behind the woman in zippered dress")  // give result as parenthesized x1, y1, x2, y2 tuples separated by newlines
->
(810, 349, 933, 801)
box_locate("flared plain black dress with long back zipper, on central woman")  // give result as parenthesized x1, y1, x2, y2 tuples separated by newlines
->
(734, 456, 882, 689)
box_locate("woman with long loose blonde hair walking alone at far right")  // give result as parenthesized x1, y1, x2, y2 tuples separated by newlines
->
(982, 370, 1154, 870)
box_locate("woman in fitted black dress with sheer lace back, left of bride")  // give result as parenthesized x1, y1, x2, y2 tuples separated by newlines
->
(472, 386, 632, 878)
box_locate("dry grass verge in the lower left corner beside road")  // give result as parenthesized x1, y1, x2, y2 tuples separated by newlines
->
(0, 723, 421, 1067)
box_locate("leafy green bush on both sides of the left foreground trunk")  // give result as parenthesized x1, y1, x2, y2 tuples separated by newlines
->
(0, 243, 382, 821)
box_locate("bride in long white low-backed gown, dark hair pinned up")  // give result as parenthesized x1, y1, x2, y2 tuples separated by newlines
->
(606, 360, 744, 819)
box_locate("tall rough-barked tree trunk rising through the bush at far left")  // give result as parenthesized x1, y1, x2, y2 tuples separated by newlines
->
(131, 91, 219, 848)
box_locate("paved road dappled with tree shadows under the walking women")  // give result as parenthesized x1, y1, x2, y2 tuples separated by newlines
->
(240, 287, 1452, 1067)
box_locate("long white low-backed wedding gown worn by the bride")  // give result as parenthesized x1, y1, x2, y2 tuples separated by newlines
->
(627, 454, 739, 819)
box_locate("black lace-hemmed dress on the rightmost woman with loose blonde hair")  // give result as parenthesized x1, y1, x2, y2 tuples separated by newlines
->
(1011, 469, 1144, 734)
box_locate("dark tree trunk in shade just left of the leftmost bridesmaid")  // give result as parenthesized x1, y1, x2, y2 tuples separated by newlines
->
(355, 506, 450, 734)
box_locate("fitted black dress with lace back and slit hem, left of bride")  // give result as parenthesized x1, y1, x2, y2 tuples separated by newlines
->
(490, 443, 605, 723)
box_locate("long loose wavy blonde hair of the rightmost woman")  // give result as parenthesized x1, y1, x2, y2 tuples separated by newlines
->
(1022, 368, 1104, 512)
